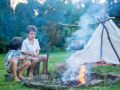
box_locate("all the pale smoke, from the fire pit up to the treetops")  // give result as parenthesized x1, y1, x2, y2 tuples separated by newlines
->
(62, 0, 108, 81)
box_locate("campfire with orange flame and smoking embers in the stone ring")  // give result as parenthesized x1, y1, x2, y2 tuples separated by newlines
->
(62, 65, 88, 86)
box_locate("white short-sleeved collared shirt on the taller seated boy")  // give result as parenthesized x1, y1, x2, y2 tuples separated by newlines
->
(21, 38, 40, 52)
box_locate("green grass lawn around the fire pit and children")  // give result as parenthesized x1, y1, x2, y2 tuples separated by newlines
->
(0, 52, 120, 90)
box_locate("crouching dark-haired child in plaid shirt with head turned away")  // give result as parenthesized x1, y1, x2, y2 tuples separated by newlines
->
(5, 37, 31, 81)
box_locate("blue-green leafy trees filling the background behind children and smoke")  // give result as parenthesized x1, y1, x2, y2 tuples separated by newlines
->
(0, 0, 120, 53)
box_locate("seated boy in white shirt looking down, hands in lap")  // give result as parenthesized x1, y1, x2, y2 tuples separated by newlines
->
(21, 25, 47, 77)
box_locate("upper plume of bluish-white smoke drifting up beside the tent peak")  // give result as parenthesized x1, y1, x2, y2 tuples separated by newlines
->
(66, 1, 108, 51)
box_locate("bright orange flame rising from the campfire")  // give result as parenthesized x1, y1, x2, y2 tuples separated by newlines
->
(78, 65, 86, 84)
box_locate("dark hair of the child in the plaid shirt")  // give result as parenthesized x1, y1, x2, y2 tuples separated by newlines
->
(9, 37, 23, 50)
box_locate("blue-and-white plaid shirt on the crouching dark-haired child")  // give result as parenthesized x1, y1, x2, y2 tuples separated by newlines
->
(5, 50, 22, 68)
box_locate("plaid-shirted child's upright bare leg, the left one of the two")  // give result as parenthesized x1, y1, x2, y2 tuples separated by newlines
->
(11, 59, 20, 81)
